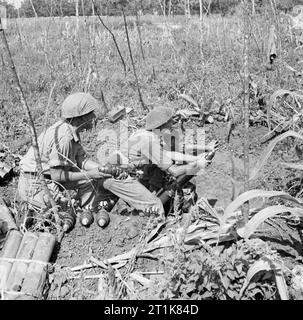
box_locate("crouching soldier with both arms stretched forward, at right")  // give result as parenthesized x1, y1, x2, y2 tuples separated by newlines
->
(120, 106, 218, 212)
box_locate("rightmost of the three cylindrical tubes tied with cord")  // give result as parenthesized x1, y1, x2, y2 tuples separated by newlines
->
(22, 232, 56, 299)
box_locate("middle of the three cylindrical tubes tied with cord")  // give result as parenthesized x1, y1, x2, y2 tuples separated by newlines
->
(7, 232, 38, 291)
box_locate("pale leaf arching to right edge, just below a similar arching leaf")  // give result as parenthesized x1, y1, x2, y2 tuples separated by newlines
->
(243, 205, 303, 239)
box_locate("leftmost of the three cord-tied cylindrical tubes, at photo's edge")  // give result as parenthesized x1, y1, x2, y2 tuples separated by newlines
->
(0, 230, 22, 290)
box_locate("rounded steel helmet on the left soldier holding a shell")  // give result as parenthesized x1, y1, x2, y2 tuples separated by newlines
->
(61, 92, 99, 119)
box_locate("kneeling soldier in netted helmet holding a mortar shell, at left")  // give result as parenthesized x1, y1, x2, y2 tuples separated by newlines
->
(18, 93, 164, 228)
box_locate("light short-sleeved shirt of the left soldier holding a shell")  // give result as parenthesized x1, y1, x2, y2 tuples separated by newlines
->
(20, 120, 86, 173)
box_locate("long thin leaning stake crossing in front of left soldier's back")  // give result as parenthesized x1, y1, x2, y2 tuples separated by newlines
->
(0, 18, 59, 215)
